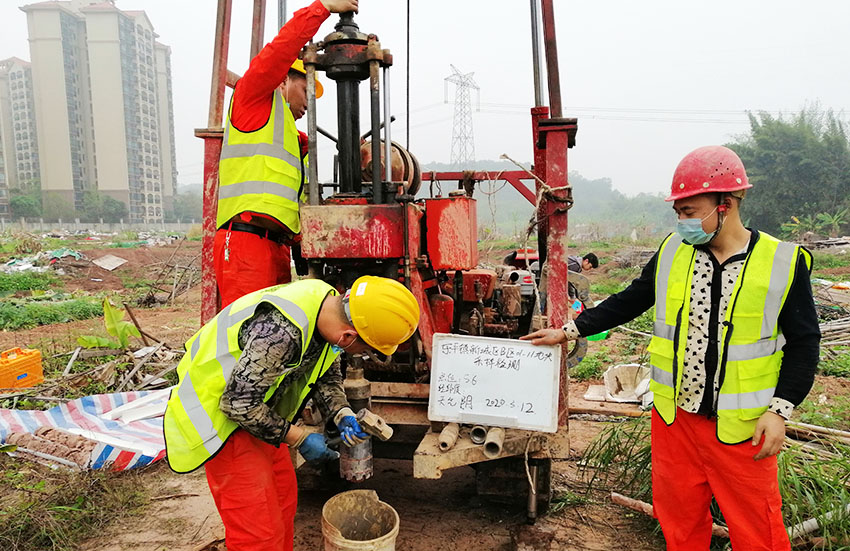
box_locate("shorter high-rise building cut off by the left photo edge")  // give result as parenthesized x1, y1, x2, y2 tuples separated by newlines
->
(0, 57, 41, 216)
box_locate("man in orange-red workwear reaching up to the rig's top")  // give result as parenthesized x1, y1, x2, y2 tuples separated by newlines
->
(213, 0, 358, 308)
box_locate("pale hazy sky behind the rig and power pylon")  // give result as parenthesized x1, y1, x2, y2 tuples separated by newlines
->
(0, 0, 850, 194)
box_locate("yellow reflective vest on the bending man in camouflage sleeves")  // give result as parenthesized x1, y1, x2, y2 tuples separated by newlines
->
(164, 279, 339, 473)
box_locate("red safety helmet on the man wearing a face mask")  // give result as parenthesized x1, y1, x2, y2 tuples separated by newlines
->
(665, 145, 753, 201)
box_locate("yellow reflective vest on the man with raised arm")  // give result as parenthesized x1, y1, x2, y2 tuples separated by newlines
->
(216, 90, 306, 233)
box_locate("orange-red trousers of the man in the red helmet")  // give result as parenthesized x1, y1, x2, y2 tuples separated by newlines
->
(652, 409, 791, 551)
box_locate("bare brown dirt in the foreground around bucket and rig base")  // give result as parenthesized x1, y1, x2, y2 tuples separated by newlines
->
(68, 383, 663, 551)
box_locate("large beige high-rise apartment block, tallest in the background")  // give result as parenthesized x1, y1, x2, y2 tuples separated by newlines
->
(21, 0, 176, 222)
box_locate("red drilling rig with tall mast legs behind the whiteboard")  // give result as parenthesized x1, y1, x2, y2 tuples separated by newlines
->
(196, 0, 592, 518)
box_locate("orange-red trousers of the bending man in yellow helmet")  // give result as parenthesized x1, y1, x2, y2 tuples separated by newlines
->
(204, 429, 298, 551)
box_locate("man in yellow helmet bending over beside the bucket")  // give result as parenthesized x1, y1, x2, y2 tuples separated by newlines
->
(164, 276, 419, 551)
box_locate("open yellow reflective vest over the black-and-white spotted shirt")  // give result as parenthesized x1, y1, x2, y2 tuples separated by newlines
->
(649, 232, 812, 444)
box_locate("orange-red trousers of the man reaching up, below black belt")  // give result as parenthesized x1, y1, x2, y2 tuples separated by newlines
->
(213, 229, 292, 308)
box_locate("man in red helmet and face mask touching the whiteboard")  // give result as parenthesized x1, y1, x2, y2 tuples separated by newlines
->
(524, 146, 820, 551)
